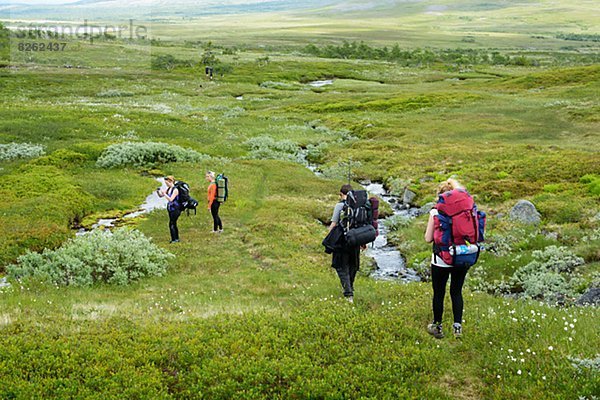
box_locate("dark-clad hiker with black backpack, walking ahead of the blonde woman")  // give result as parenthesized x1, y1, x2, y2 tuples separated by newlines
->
(323, 185, 376, 303)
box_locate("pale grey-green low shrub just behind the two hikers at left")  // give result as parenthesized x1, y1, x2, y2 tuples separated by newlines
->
(96, 142, 209, 168)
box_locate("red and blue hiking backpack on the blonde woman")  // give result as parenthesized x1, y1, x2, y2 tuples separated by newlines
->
(433, 189, 486, 267)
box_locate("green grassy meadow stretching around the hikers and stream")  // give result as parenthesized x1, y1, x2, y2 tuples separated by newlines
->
(0, 1, 600, 399)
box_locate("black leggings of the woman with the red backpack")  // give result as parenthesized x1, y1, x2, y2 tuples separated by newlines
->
(431, 265, 469, 324)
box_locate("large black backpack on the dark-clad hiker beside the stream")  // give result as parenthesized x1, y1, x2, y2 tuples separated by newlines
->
(343, 190, 377, 247)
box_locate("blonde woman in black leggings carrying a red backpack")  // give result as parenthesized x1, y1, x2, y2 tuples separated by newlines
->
(425, 179, 485, 339)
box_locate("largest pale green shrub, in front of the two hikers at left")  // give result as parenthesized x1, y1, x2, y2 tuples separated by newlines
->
(7, 228, 174, 286)
